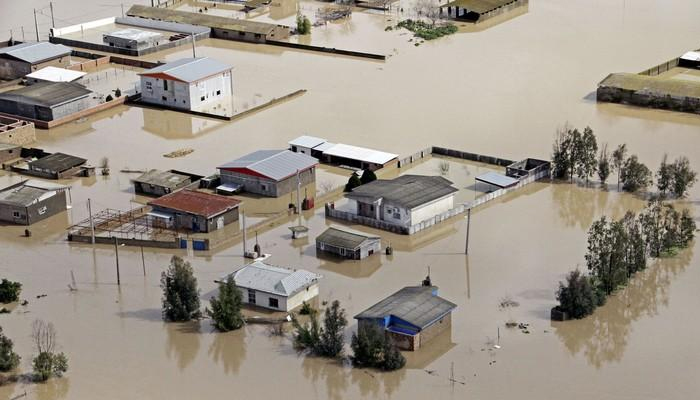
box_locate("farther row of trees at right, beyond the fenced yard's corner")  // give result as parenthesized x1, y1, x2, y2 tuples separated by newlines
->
(552, 125, 697, 198)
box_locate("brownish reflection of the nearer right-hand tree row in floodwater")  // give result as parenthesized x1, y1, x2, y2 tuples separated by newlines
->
(552, 248, 693, 368)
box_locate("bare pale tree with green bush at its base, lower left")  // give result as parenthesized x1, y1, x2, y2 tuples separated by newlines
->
(32, 320, 68, 382)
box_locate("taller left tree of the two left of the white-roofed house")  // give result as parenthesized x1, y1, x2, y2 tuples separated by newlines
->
(160, 256, 200, 322)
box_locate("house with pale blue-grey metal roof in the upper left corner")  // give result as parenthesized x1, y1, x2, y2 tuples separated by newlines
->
(0, 42, 72, 80)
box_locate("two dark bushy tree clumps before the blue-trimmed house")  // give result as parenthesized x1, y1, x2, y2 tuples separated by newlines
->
(292, 300, 406, 371)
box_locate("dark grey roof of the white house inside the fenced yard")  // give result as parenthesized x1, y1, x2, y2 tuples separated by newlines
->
(345, 175, 457, 210)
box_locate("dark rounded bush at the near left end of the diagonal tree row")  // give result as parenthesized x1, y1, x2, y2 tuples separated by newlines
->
(556, 269, 604, 319)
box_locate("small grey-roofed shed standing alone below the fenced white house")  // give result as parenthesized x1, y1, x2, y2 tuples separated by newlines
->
(316, 226, 382, 260)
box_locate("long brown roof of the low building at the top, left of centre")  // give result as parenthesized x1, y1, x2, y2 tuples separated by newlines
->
(126, 5, 289, 35)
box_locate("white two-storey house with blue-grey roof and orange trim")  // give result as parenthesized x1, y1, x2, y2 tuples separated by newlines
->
(139, 57, 233, 113)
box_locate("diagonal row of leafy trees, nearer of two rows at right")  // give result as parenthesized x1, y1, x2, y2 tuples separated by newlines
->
(556, 199, 697, 318)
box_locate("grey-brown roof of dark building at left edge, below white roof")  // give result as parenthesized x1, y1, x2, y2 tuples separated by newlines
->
(0, 82, 92, 107)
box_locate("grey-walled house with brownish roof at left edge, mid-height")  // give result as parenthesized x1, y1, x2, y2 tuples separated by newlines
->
(0, 180, 68, 225)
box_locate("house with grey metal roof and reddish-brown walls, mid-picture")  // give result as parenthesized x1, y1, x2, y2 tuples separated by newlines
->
(218, 150, 318, 197)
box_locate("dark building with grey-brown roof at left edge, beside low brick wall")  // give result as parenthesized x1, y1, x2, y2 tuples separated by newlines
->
(0, 82, 92, 121)
